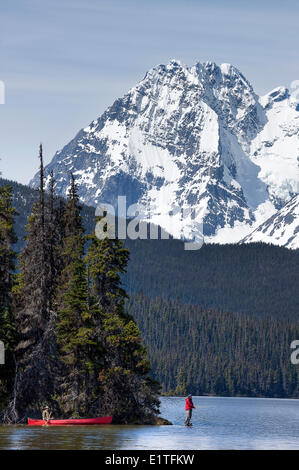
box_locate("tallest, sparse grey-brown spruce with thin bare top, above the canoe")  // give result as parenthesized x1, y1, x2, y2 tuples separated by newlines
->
(6, 145, 59, 421)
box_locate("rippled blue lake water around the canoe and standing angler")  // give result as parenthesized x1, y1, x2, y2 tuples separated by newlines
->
(0, 397, 299, 450)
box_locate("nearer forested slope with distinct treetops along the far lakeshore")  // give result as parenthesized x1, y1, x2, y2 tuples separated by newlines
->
(128, 294, 299, 398)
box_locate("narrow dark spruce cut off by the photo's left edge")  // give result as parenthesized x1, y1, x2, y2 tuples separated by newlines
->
(0, 186, 17, 412)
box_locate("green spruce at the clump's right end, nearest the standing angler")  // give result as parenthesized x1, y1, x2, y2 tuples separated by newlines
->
(86, 235, 159, 423)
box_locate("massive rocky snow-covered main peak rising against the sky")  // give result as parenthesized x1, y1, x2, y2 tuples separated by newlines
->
(31, 61, 299, 242)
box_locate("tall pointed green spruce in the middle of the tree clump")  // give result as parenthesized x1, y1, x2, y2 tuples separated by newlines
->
(56, 175, 99, 416)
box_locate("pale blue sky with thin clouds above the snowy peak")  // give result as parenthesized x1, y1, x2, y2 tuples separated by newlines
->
(0, 0, 299, 183)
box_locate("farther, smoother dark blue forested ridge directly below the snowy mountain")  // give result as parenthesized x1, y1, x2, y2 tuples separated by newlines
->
(0, 179, 299, 320)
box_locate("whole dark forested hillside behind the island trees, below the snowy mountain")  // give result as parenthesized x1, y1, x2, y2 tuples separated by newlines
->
(0, 176, 299, 397)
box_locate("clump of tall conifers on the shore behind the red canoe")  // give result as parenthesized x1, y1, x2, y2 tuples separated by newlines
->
(0, 146, 166, 425)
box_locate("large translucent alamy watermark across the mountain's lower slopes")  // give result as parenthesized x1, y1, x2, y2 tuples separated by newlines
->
(95, 196, 204, 250)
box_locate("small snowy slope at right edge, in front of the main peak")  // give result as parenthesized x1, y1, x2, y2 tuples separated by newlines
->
(242, 194, 299, 249)
